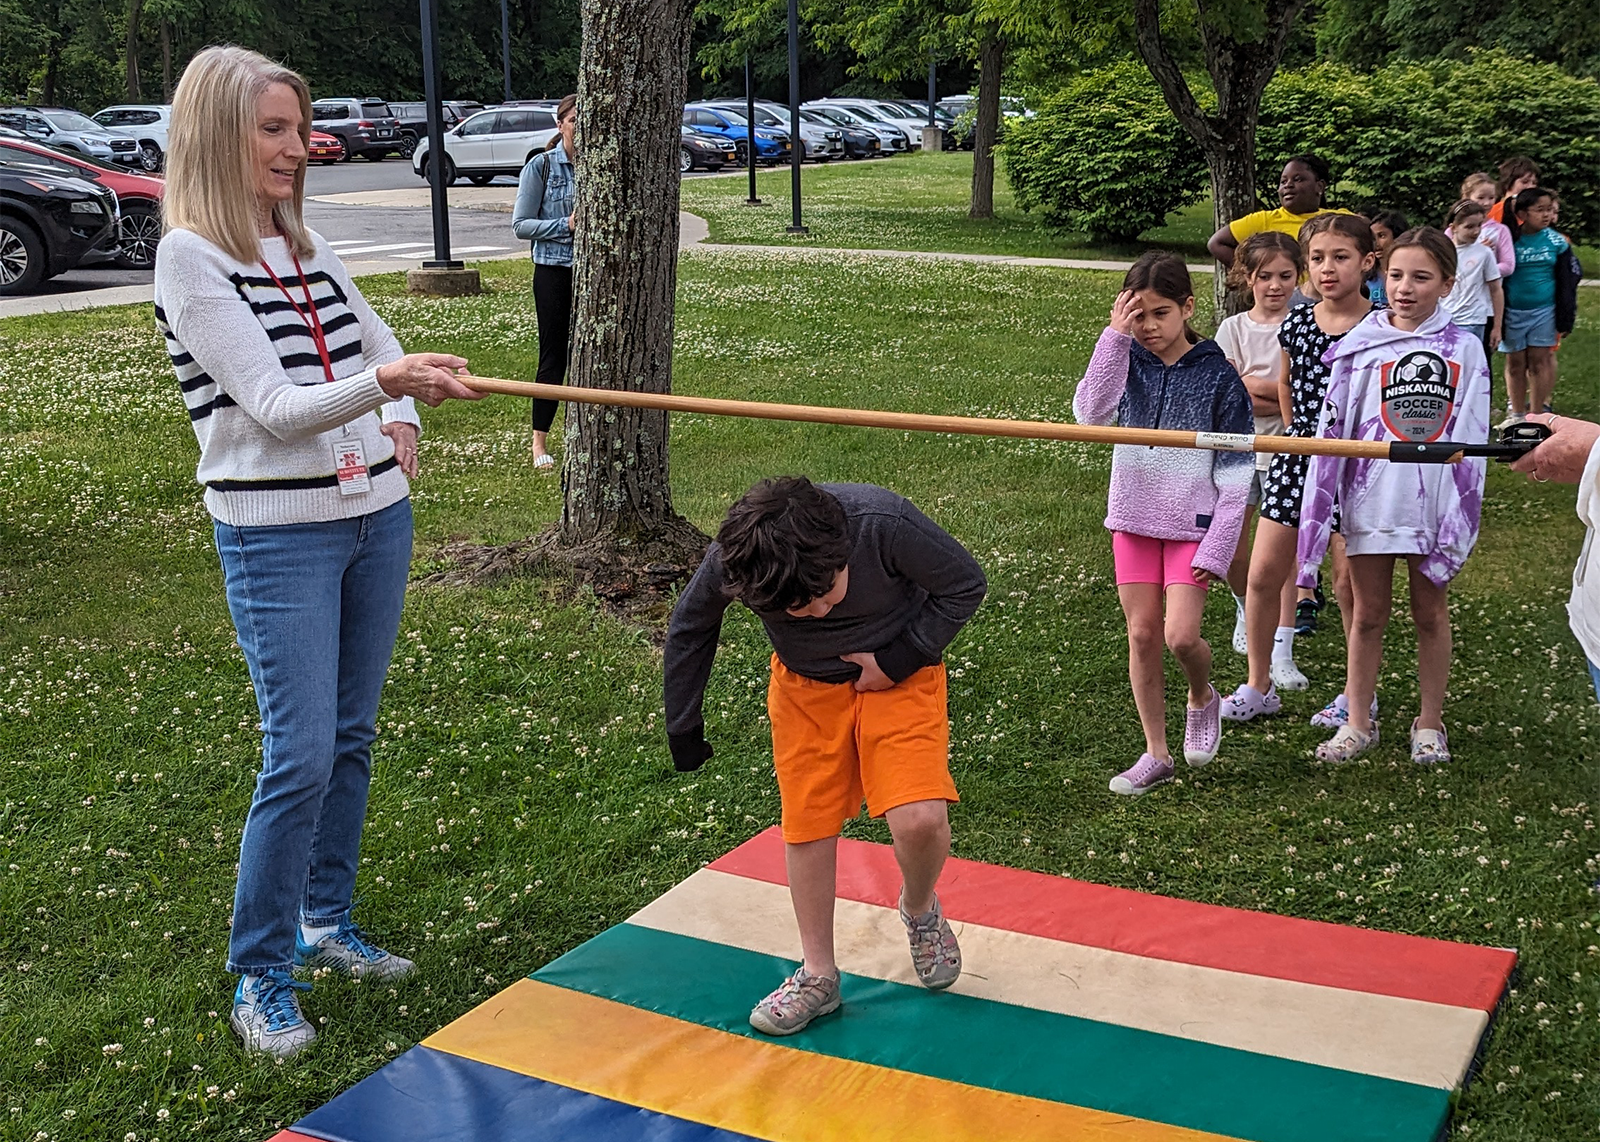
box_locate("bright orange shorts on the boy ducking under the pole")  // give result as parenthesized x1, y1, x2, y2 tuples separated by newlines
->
(766, 654, 960, 845)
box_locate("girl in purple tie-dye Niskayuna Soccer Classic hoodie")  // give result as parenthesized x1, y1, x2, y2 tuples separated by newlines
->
(1298, 227, 1490, 765)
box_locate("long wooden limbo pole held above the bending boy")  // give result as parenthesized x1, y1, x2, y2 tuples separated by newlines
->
(458, 376, 1526, 464)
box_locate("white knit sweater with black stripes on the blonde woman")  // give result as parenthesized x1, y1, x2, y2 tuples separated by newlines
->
(155, 230, 418, 526)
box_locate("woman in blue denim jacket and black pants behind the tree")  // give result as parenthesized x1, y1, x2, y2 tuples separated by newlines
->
(510, 96, 578, 472)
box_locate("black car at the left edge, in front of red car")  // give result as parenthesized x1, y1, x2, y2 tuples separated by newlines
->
(0, 165, 117, 297)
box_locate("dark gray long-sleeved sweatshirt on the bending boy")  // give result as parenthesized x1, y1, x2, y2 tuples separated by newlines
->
(664, 483, 989, 768)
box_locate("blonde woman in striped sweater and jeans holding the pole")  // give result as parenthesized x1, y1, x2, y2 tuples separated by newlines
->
(155, 48, 478, 1057)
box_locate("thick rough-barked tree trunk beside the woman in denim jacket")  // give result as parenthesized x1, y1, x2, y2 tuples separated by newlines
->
(558, 0, 706, 563)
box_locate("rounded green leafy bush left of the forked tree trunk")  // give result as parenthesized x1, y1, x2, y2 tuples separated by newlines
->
(998, 62, 1206, 242)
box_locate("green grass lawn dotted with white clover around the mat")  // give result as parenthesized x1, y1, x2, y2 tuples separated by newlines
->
(0, 251, 1600, 1142)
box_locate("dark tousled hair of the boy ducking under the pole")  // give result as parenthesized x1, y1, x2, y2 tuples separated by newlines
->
(717, 477, 850, 611)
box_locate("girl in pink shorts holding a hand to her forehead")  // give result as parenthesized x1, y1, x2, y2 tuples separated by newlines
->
(1072, 251, 1254, 795)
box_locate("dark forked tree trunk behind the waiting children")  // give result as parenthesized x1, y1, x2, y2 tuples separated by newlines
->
(1133, 0, 1306, 320)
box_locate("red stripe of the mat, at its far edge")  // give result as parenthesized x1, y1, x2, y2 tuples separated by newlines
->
(710, 829, 1517, 1011)
